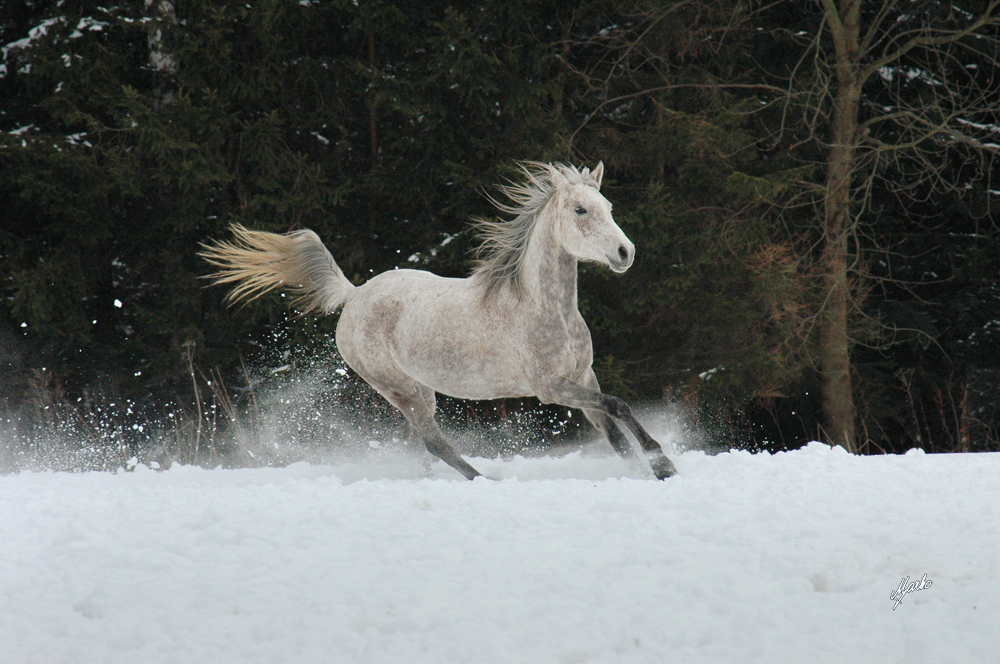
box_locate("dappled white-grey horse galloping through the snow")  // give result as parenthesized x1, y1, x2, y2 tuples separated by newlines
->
(201, 162, 676, 480)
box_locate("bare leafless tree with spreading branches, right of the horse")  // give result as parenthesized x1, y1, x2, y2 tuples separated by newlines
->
(577, 0, 1000, 452)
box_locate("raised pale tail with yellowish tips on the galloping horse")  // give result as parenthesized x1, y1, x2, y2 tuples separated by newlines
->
(198, 224, 354, 314)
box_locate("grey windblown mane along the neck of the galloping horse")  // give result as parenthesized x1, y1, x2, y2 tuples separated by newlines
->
(472, 161, 599, 299)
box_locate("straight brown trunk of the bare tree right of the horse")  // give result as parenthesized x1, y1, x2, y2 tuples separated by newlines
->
(820, 0, 861, 452)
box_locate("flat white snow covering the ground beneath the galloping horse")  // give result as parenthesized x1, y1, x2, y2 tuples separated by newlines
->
(0, 443, 1000, 663)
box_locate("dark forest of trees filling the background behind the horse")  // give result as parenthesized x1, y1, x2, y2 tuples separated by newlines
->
(0, 0, 1000, 461)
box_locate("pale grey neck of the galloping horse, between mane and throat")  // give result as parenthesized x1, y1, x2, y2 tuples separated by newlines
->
(522, 205, 577, 315)
